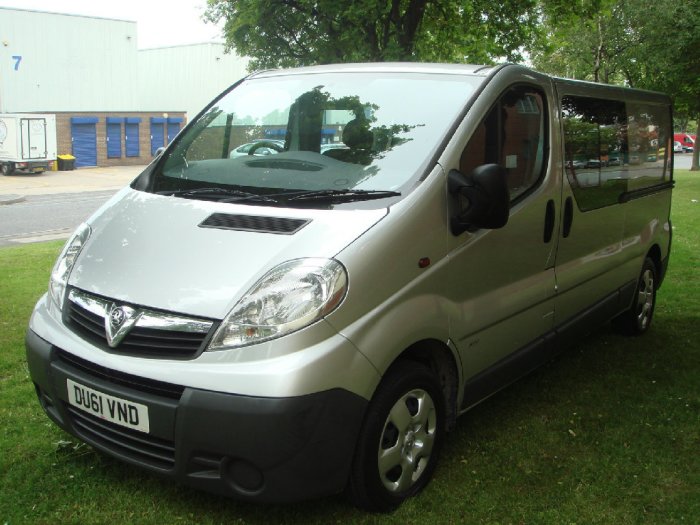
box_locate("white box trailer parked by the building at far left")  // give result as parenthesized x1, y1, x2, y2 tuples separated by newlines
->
(0, 113, 56, 175)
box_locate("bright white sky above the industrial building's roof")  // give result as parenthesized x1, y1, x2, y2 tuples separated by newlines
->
(0, 0, 223, 49)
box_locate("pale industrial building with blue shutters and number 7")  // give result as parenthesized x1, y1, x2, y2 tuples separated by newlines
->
(0, 7, 247, 167)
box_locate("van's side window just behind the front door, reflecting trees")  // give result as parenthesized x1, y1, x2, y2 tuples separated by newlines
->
(562, 96, 630, 211)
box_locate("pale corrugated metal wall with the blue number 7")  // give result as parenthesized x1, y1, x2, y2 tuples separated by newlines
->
(0, 8, 138, 112)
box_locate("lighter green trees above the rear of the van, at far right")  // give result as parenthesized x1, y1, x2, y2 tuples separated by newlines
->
(533, 0, 700, 170)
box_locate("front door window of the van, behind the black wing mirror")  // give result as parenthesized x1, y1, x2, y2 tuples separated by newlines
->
(460, 86, 547, 202)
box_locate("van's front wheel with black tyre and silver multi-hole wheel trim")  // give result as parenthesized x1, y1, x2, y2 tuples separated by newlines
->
(348, 362, 445, 512)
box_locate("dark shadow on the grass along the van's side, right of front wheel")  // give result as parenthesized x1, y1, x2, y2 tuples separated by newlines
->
(456, 316, 700, 434)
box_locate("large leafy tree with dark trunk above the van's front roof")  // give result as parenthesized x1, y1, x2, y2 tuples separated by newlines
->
(205, 0, 537, 69)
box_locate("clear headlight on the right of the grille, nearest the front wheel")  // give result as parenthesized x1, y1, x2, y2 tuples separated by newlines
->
(209, 259, 348, 350)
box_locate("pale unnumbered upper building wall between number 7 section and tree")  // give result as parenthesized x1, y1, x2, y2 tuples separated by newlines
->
(138, 42, 248, 120)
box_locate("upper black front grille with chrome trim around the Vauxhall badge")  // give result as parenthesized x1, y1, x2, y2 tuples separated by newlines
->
(65, 289, 214, 359)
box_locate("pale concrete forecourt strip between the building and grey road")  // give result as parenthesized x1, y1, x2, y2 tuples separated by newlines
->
(0, 166, 145, 205)
